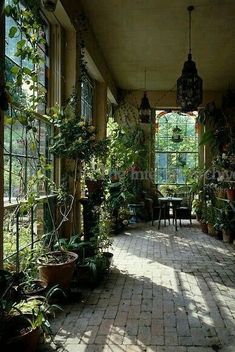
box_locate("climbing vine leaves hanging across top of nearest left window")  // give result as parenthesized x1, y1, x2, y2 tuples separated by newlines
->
(5, 0, 46, 110)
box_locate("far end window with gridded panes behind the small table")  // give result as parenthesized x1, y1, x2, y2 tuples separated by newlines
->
(155, 111, 198, 185)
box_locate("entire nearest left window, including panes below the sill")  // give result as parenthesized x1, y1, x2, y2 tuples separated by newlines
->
(4, 0, 55, 269)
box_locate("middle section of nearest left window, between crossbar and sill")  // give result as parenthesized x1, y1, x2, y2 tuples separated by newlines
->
(4, 114, 52, 203)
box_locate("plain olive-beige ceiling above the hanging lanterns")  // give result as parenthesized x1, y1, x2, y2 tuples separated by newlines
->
(82, 0, 235, 91)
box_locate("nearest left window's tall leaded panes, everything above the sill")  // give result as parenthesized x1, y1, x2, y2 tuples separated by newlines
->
(4, 0, 51, 203)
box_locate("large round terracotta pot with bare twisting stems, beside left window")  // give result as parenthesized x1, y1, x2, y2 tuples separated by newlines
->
(39, 251, 78, 289)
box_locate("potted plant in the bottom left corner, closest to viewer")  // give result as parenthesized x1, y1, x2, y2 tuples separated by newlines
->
(0, 271, 61, 352)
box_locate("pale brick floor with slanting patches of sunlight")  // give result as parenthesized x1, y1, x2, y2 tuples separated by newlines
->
(39, 223, 235, 352)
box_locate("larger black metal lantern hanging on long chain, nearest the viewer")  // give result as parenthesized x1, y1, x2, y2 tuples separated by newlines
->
(177, 6, 202, 112)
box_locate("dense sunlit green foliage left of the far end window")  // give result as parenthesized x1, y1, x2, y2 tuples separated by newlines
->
(106, 120, 148, 213)
